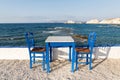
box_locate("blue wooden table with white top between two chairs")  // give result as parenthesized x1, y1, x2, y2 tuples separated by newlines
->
(45, 36, 75, 73)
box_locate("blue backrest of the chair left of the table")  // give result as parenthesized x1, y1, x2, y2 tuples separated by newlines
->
(25, 32, 35, 52)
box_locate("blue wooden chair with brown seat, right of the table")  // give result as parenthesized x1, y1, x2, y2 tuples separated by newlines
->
(75, 32, 96, 70)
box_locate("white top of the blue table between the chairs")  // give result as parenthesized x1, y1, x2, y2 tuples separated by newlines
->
(45, 36, 74, 42)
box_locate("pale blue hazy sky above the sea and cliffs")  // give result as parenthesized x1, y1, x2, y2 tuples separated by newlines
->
(0, 0, 120, 23)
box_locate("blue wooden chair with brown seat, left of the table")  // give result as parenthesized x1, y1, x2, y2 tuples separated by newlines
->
(25, 32, 46, 70)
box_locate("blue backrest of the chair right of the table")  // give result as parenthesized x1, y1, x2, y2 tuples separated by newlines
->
(88, 32, 96, 53)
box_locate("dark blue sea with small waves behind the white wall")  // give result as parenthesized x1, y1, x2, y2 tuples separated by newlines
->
(0, 23, 120, 47)
